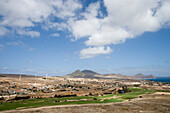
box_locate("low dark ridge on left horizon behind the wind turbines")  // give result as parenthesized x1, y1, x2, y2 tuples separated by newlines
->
(0, 74, 40, 78)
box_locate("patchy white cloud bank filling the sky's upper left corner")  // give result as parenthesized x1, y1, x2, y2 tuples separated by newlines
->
(0, 0, 82, 37)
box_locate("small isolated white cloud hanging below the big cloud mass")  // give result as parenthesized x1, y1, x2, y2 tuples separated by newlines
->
(80, 46, 112, 59)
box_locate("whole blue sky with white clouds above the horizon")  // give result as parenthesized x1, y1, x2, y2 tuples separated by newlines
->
(0, 0, 170, 76)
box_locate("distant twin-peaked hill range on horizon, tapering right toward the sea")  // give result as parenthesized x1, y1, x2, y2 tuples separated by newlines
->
(66, 70, 156, 79)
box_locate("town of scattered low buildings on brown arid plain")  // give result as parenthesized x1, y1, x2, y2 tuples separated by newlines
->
(0, 72, 170, 103)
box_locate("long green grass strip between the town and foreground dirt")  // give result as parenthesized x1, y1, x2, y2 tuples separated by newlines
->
(0, 88, 155, 111)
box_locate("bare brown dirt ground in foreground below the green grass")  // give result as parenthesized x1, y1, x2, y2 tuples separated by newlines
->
(0, 92, 170, 113)
